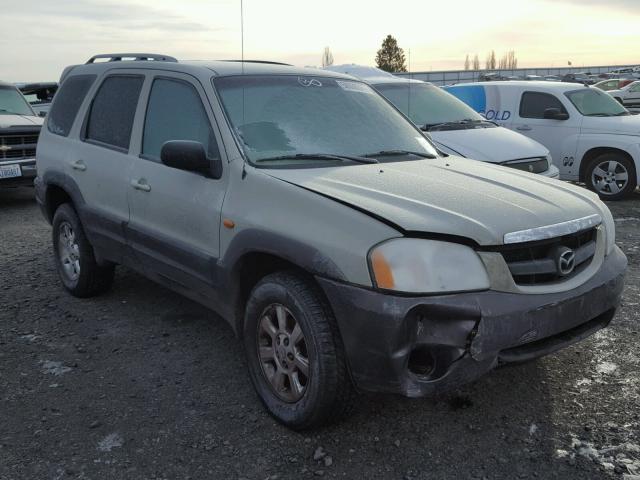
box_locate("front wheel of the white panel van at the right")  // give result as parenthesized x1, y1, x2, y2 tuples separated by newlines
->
(585, 152, 637, 200)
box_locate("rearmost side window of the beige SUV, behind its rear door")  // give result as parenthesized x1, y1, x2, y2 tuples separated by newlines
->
(47, 75, 96, 137)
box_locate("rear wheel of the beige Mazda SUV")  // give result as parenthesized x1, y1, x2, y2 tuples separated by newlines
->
(52, 203, 115, 298)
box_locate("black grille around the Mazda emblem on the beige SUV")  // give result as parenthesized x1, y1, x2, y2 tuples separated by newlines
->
(498, 227, 597, 285)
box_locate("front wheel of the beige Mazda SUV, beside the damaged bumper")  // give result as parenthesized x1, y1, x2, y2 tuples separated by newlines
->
(243, 272, 355, 430)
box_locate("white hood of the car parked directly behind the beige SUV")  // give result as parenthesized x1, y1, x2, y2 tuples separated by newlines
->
(429, 127, 549, 163)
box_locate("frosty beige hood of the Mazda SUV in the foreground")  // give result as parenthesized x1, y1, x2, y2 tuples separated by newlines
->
(261, 156, 606, 245)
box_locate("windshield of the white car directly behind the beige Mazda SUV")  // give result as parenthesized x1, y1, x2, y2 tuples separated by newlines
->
(375, 82, 484, 125)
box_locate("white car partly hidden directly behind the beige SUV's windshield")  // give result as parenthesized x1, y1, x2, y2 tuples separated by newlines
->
(325, 64, 559, 178)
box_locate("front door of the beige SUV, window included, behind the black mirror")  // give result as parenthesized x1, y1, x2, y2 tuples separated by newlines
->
(127, 72, 227, 294)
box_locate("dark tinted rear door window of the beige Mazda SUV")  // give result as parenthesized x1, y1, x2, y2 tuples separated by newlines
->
(85, 75, 144, 151)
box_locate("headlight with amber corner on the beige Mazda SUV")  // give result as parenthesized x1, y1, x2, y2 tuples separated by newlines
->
(369, 238, 490, 293)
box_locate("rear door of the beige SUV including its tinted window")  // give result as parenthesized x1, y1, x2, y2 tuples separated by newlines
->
(68, 70, 145, 263)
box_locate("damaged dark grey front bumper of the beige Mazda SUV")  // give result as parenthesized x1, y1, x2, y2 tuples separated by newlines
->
(318, 247, 627, 397)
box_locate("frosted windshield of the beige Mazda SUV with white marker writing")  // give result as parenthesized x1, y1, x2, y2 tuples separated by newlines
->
(214, 75, 437, 166)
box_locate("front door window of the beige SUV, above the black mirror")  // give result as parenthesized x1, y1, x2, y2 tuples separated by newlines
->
(142, 78, 219, 160)
